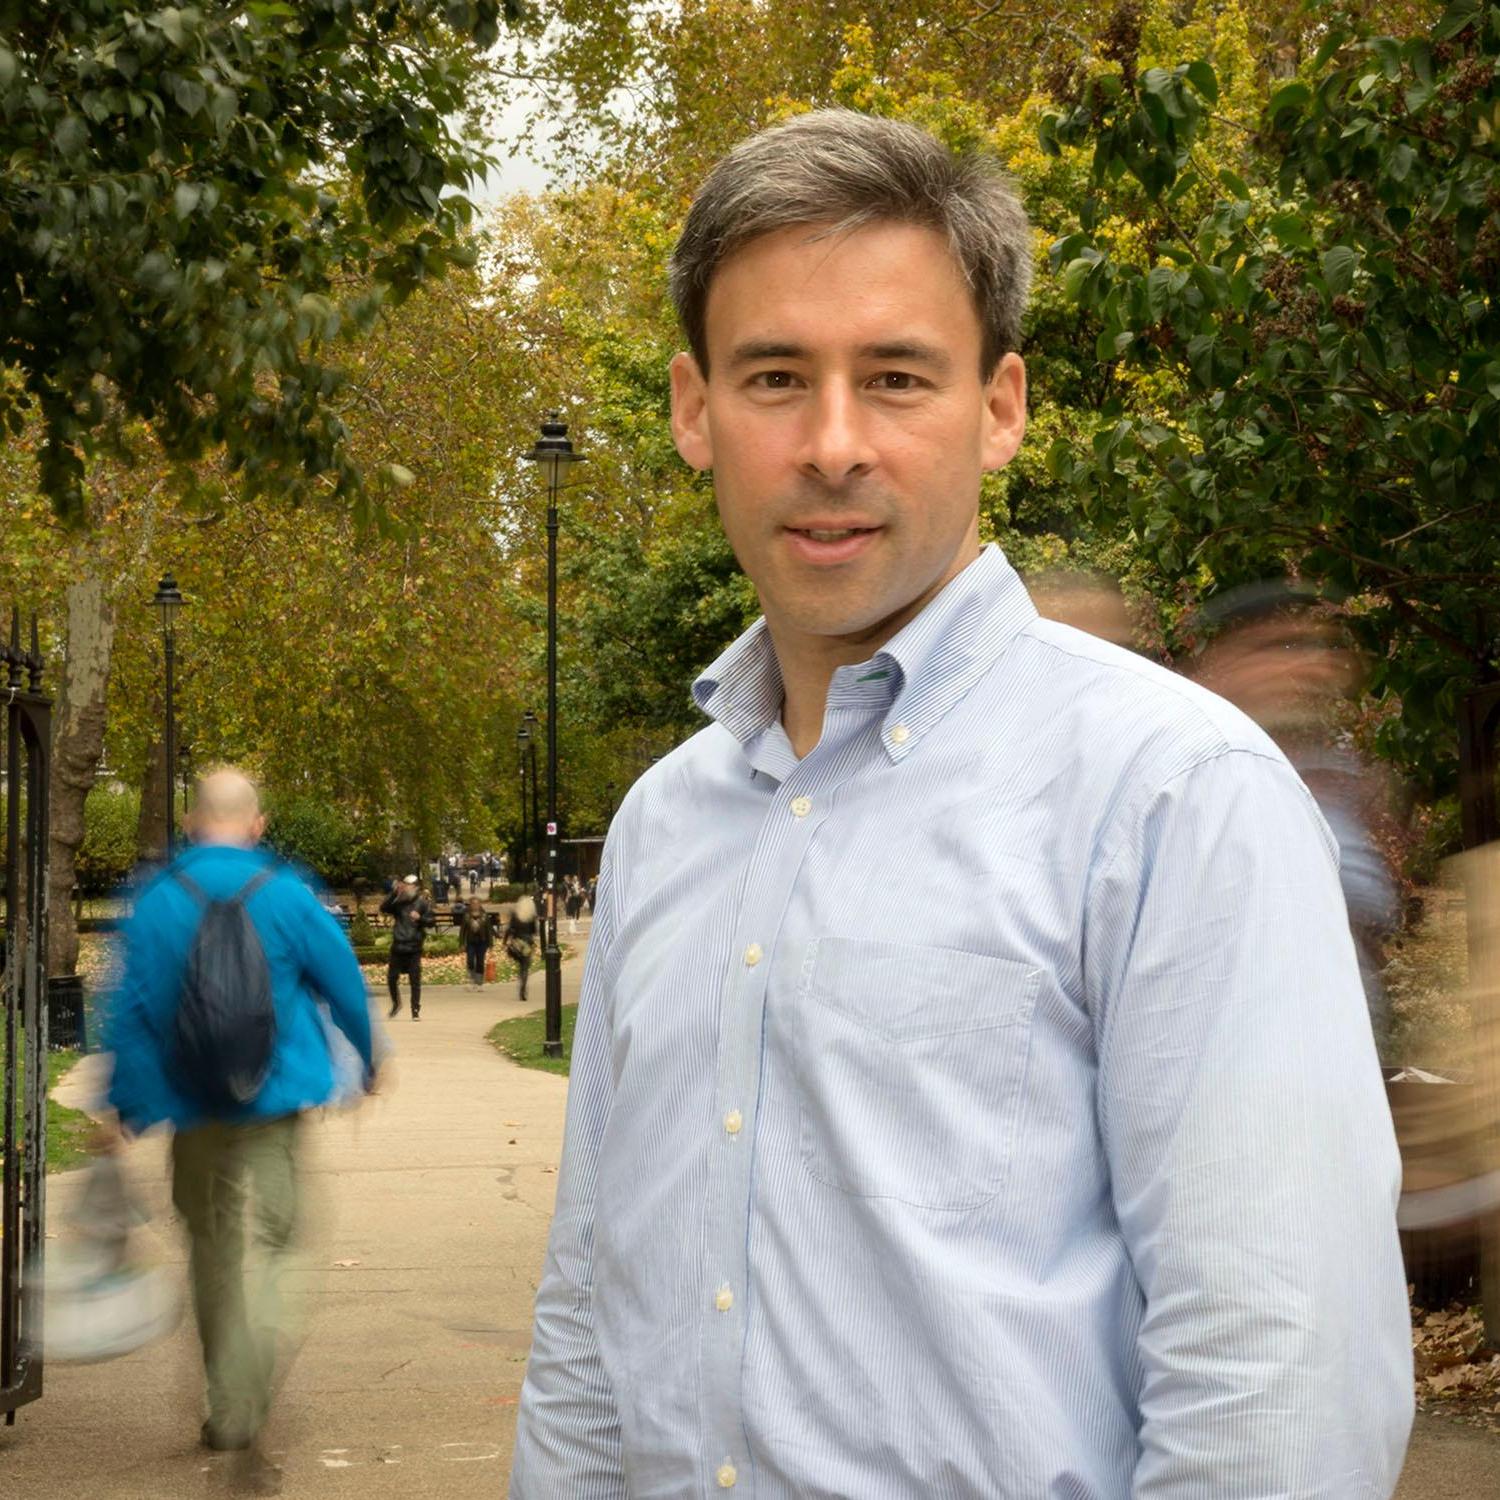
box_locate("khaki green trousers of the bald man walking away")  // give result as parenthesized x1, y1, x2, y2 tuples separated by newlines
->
(173, 1115, 300, 1443)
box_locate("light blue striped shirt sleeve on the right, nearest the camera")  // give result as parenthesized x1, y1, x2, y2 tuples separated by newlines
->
(1088, 750, 1413, 1500)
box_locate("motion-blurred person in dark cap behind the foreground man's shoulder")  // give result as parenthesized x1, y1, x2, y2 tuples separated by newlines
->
(1188, 579, 1401, 1062)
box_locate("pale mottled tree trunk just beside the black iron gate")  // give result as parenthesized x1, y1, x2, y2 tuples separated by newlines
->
(47, 564, 116, 977)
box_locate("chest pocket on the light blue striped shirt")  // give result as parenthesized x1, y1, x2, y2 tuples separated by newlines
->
(795, 938, 1041, 1211)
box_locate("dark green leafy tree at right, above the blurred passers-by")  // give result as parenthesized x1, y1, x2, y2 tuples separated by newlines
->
(1043, 0, 1500, 792)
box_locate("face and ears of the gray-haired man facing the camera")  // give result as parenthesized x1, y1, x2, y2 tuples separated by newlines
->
(672, 224, 1026, 653)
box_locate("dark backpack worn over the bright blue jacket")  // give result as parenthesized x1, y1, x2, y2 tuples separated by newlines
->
(173, 867, 278, 1112)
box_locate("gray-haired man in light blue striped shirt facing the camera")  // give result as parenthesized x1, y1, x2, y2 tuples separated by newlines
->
(512, 111, 1412, 1500)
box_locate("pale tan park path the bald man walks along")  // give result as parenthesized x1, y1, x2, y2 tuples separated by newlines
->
(0, 912, 1500, 1500)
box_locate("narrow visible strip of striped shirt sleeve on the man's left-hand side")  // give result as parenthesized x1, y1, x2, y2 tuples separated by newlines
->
(510, 851, 627, 1500)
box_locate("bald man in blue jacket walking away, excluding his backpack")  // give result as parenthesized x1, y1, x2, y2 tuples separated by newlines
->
(105, 770, 375, 1488)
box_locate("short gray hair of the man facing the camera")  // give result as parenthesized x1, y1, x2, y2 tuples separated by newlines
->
(672, 110, 1032, 378)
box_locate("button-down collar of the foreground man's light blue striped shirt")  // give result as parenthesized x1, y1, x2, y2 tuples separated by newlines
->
(693, 543, 1037, 761)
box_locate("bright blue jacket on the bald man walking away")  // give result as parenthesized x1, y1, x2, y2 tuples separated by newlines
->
(105, 845, 374, 1131)
